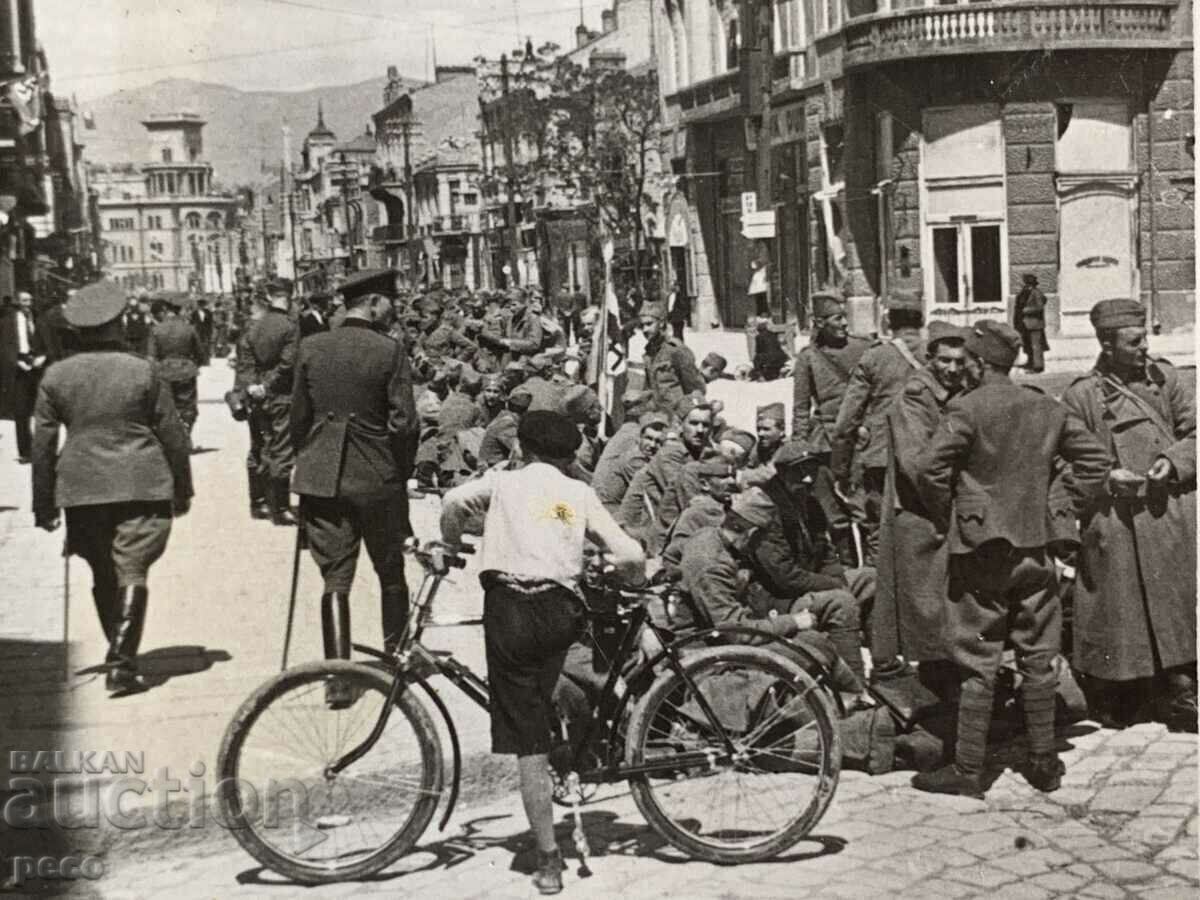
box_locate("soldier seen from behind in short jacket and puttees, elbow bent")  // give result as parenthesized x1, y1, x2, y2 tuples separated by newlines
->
(912, 319, 1110, 797)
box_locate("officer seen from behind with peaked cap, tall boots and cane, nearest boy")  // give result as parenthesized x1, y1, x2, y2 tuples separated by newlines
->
(292, 269, 418, 708)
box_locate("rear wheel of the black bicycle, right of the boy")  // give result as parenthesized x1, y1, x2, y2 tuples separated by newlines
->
(626, 646, 841, 863)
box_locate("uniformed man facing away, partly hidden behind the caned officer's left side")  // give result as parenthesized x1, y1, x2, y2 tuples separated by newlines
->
(246, 278, 300, 526)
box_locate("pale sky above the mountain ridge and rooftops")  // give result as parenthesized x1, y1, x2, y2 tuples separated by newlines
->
(36, 0, 610, 101)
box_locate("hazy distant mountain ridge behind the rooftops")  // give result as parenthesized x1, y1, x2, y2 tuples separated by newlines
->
(78, 77, 421, 187)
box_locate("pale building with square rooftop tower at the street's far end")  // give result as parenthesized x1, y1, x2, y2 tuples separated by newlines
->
(91, 113, 240, 294)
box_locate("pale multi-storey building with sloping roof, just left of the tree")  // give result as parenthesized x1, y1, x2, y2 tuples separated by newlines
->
(371, 66, 492, 288)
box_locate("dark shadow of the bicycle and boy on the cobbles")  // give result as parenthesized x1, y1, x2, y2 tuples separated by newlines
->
(236, 810, 846, 887)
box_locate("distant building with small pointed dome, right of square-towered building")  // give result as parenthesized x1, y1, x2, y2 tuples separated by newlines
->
(289, 103, 378, 280)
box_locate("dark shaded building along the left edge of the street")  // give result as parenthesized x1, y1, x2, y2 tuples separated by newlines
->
(0, 0, 95, 303)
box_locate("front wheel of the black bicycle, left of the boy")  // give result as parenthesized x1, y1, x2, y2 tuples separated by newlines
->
(217, 660, 443, 884)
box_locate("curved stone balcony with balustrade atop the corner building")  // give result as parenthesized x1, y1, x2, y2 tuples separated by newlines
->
(842, 0, 1187, 70)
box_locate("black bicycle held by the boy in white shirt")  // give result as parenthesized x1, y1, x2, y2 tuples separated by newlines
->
(217, 539, 841, 884)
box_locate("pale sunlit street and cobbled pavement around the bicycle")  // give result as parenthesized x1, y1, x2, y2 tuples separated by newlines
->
(0, 350, 1200, 898)
